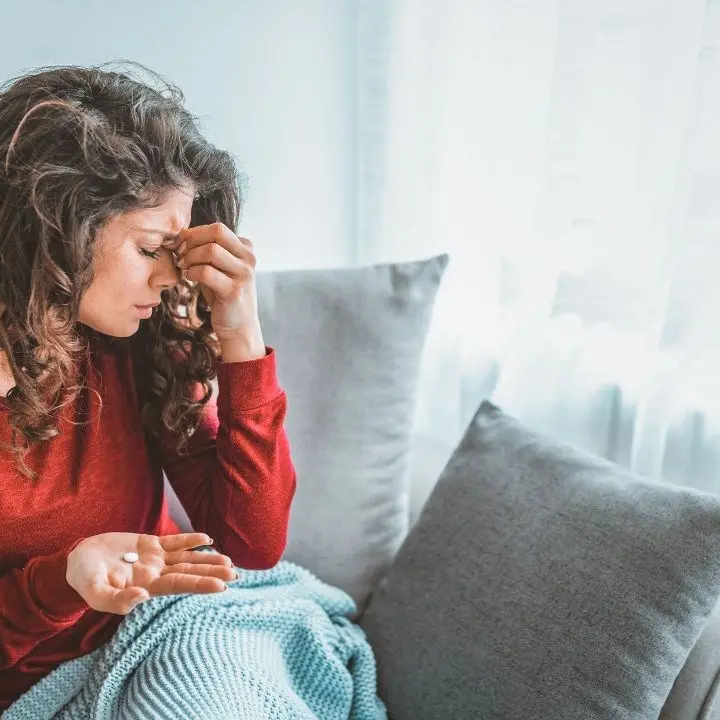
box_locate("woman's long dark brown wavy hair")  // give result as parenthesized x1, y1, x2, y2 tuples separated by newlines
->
(0, 63, 246, 479)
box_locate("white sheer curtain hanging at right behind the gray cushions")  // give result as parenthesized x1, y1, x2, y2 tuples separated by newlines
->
(357, 0, 720, 492)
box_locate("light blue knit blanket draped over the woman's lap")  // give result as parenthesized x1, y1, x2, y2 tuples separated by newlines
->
(2, 561, 387, 720)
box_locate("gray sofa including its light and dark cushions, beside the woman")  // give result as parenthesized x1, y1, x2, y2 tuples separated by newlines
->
(167, 255, 720, 720)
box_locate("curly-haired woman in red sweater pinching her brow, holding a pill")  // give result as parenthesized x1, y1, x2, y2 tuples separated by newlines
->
(0, 67, 295, 709)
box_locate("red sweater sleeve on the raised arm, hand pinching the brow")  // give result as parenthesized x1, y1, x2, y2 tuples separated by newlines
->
(161, 347, 296, 570)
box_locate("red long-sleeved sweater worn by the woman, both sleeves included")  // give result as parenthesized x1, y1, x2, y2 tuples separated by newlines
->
(0, 341, 295, 710)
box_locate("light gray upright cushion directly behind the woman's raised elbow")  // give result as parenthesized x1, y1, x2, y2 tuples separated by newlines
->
(257, 255, 448, 612)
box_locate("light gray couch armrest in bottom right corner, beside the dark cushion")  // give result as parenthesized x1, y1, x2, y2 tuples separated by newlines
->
(658, 605, 720, 720)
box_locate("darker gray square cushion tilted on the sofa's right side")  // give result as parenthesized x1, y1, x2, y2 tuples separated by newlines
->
(361, 403, 720, 720)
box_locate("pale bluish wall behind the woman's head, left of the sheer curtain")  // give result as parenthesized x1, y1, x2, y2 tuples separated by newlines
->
(0, 0, 356, 270)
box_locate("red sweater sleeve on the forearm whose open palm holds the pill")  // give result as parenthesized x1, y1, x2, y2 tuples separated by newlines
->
(0, 543, 89, 670)
